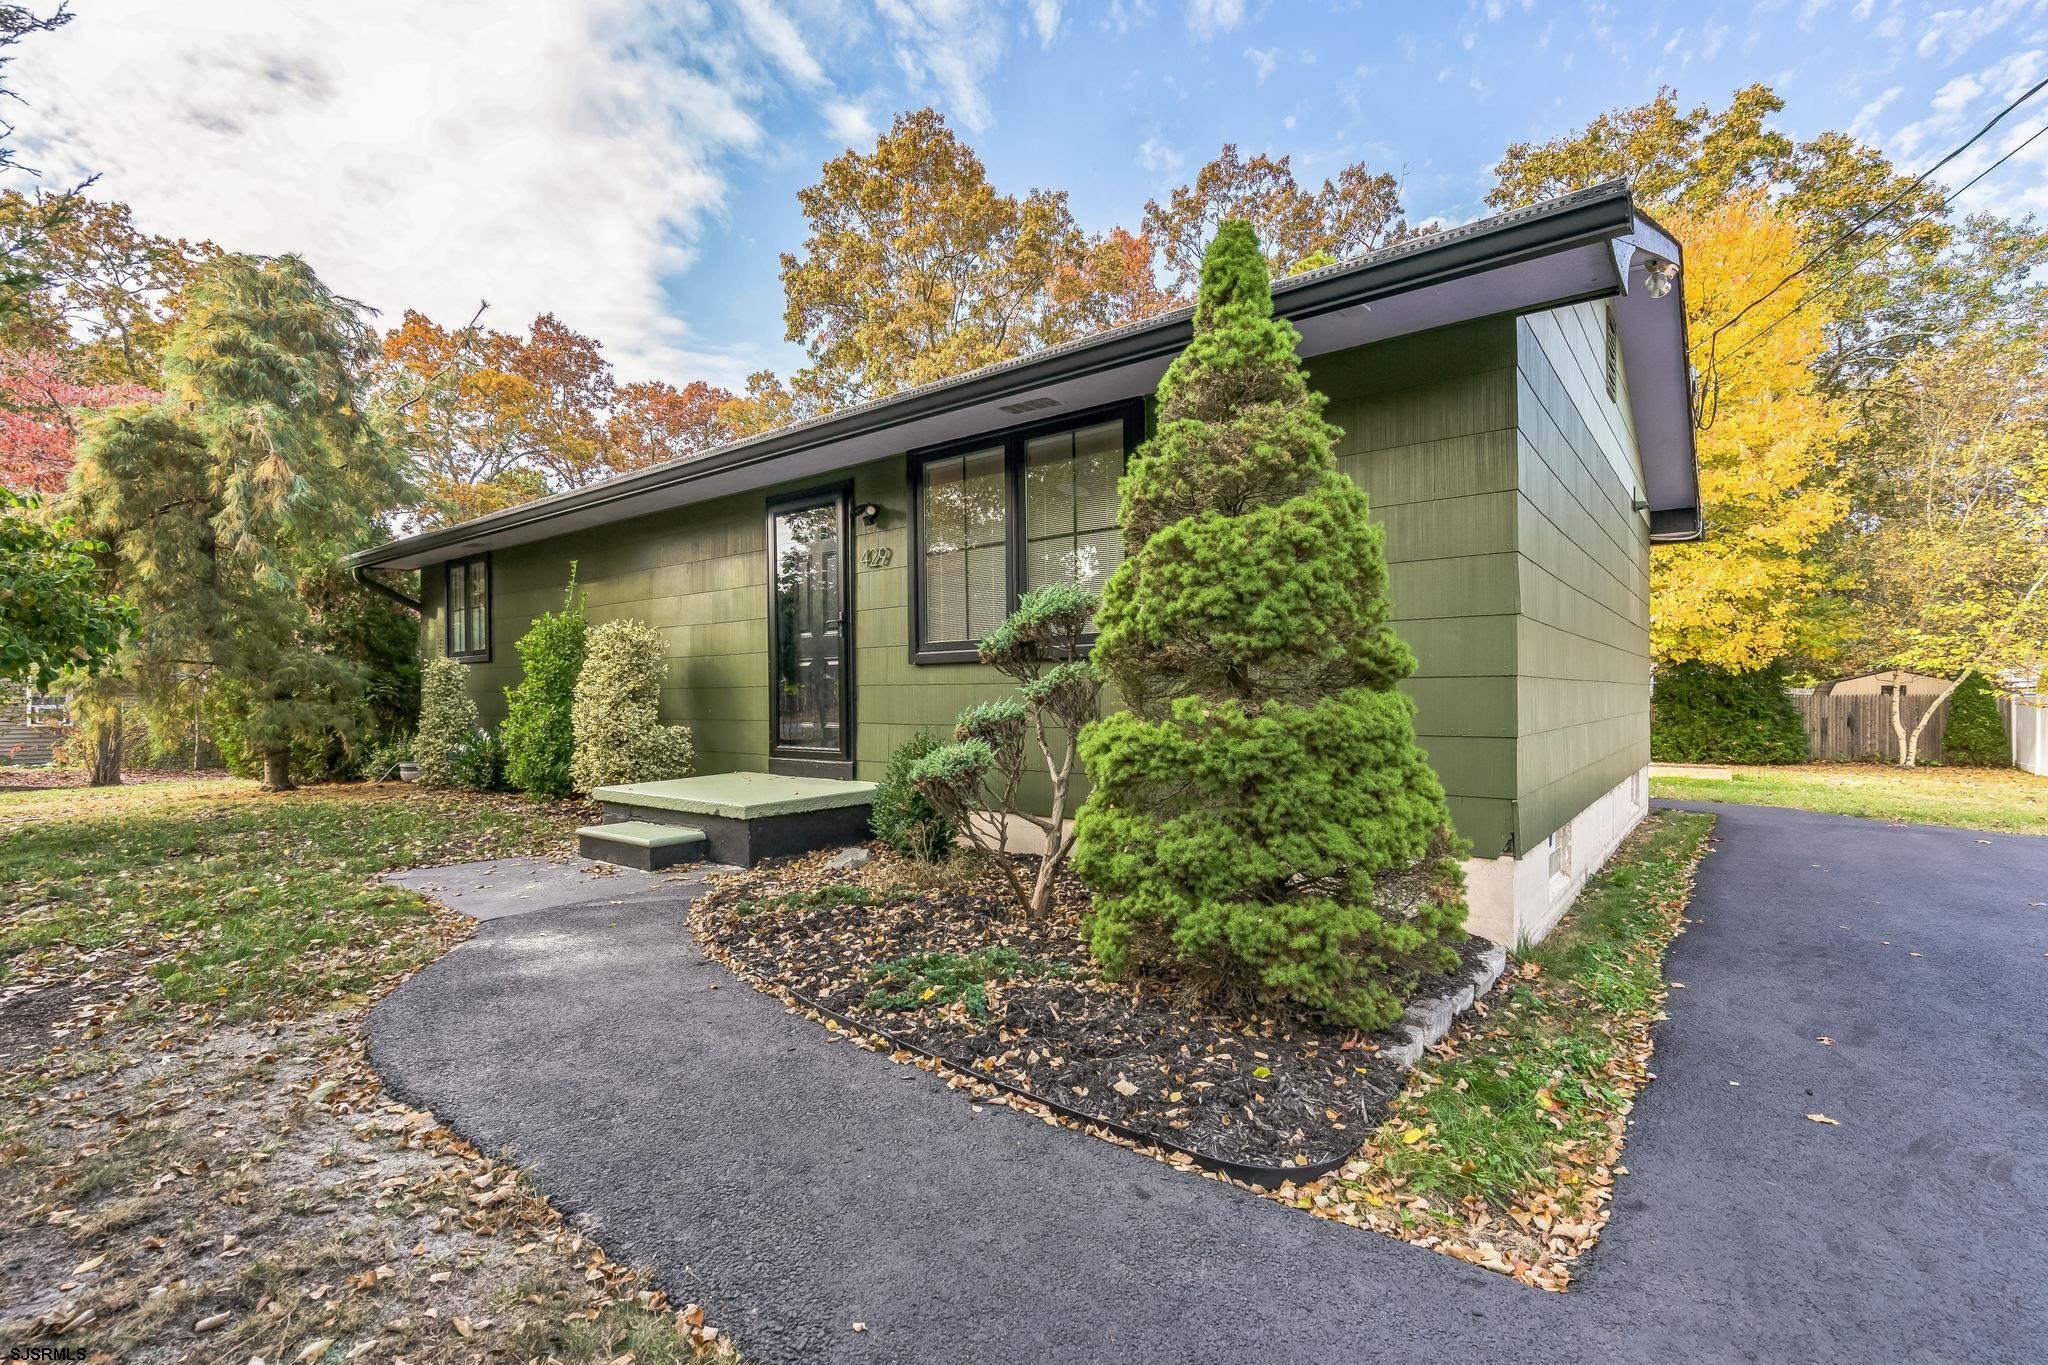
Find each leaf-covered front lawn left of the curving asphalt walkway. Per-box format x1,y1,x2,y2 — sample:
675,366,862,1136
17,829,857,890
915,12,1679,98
0,782,723,1363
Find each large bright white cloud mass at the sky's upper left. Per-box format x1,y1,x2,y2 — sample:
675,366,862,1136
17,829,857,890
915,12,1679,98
10,0,807,381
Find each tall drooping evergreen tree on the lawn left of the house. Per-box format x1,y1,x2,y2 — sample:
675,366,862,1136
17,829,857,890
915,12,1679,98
72,256,403,790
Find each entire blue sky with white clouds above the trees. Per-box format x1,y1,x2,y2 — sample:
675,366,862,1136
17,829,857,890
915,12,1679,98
14,0,2048,383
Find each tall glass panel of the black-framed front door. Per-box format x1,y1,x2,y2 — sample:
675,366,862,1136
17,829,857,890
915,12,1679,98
770,501,846,753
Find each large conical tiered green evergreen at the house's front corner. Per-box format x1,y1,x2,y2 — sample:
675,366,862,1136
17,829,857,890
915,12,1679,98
1073,221,1464,1027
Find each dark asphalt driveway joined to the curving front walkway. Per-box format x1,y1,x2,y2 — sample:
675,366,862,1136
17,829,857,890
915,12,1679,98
371,806,2048,1365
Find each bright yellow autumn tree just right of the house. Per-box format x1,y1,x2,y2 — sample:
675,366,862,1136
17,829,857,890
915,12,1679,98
1651,192,1847,669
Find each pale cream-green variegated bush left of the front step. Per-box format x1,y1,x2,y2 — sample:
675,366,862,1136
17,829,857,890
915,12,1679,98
569,620,696,792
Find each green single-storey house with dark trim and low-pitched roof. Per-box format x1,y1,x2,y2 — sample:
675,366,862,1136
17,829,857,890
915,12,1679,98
352,184,1702,943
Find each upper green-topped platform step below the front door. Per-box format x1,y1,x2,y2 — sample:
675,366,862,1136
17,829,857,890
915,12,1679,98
590,774,874,868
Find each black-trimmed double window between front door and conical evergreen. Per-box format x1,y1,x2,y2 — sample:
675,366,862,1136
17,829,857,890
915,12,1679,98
911,405,1143,663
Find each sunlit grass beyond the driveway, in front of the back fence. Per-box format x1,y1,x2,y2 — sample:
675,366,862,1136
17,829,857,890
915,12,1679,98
1651,763,2048,835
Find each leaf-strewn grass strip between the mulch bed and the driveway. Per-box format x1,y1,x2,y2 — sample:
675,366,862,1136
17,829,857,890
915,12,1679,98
1280,810,1714,1289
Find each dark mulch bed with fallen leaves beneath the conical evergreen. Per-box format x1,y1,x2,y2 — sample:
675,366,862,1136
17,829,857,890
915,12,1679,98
690,855,1485,1169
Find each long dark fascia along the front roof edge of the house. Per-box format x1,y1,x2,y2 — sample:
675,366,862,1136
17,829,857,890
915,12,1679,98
344,182,1636,567
